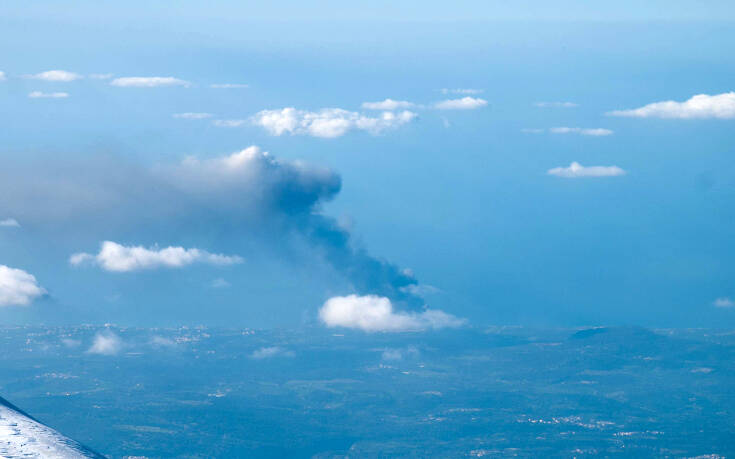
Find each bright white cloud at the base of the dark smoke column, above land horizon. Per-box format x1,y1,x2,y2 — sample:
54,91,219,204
319,295,464,332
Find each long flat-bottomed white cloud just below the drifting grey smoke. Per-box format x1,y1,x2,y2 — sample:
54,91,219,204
69,241,243,272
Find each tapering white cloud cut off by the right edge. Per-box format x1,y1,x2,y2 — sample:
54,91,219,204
607,92,735,119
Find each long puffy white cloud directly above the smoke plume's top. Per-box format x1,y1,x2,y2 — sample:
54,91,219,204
252,107,416,138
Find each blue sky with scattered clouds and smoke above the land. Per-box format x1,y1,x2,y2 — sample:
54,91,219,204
0,1,735,331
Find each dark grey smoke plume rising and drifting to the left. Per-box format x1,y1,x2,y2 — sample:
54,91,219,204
0,146,424,308
